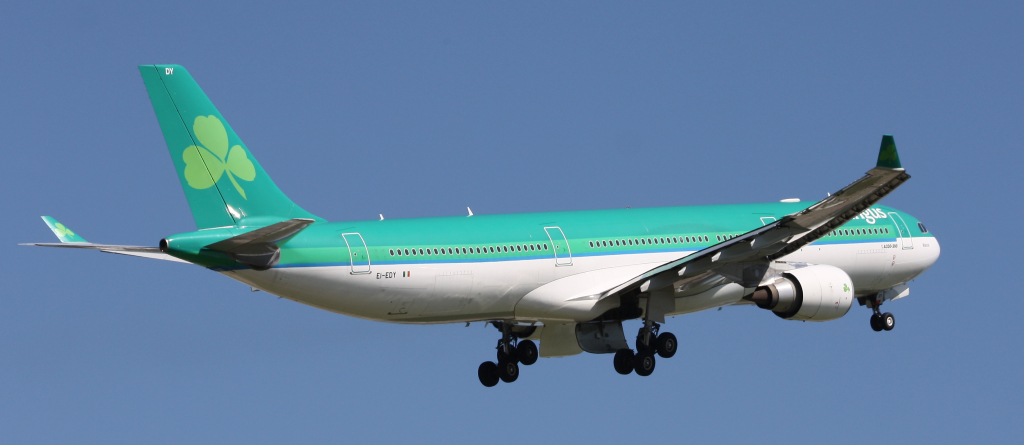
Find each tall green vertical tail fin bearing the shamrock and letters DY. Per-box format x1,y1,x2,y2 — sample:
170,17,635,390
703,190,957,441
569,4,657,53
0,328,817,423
138,64,323,229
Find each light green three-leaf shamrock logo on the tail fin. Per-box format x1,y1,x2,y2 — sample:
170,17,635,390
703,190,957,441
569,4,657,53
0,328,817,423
181,116,256,199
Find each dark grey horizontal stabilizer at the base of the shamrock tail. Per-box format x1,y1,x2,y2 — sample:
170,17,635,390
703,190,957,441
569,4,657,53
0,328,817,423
206,218,315,270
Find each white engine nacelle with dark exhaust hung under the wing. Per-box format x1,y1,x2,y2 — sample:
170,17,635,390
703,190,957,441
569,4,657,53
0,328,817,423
746,265,854,321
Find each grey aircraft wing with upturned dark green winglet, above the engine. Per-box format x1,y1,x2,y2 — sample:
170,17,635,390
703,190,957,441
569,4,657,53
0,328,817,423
600,135,910,299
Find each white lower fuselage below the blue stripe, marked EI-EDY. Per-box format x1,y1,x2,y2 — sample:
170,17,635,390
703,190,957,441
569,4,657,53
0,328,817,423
222,237,940,323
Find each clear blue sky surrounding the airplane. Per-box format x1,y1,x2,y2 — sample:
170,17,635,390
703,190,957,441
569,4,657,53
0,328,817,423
0,2,1024,444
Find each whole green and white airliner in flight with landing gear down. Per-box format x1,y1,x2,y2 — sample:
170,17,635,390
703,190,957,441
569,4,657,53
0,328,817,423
24,64,940,387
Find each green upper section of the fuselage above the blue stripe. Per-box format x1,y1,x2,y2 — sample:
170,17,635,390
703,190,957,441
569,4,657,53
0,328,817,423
237,203,931,268
